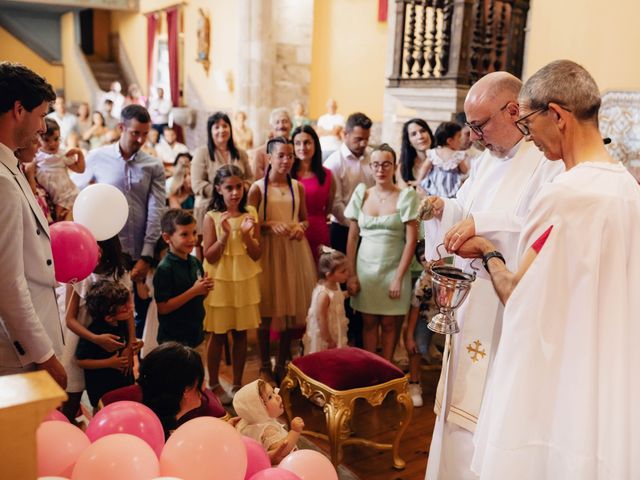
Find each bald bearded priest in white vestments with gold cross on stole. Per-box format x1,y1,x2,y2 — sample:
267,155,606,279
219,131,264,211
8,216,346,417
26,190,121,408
425,72,563,480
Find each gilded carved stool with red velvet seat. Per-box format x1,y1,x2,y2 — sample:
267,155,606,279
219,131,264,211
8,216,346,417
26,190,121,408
280,347,413,470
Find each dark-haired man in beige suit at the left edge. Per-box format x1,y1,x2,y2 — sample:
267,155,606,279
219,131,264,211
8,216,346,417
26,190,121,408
0,62,67,388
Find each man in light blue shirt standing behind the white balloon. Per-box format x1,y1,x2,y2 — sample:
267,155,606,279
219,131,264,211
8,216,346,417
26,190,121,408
78,105,166,337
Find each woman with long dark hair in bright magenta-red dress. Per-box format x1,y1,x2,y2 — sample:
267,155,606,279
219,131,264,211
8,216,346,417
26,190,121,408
291,125,336,264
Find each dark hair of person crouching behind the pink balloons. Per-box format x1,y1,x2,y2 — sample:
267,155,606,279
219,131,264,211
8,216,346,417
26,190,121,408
138,342,204,437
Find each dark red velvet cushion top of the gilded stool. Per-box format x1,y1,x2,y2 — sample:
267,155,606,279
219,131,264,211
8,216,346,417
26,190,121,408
292,347,404,390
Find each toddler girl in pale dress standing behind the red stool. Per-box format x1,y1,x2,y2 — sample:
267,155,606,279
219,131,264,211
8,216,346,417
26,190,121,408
302,246,349,355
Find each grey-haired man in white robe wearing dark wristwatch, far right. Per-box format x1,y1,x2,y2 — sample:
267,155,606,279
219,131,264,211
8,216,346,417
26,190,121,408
458,60,640,480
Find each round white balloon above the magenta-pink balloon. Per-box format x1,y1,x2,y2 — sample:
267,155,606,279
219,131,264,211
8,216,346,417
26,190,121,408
73,183,129,241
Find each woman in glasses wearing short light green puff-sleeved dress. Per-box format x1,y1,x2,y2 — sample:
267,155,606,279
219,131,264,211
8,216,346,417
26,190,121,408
345,143,418,360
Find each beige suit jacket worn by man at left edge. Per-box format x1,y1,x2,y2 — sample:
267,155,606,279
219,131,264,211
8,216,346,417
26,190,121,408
0,143,64,372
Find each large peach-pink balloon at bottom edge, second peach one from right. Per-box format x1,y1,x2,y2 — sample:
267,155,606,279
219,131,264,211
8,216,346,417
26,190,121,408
160,417,247,480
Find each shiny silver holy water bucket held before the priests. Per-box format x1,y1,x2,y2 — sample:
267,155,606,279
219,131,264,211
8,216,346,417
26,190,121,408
427,245,476,335
